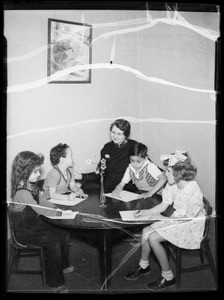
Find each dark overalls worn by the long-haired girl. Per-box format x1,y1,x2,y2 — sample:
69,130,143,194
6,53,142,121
11,189,70,287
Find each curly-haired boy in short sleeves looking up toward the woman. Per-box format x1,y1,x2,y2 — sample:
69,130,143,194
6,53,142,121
43,143,88,200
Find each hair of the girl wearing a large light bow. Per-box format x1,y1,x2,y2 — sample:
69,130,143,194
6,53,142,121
163,152,197,183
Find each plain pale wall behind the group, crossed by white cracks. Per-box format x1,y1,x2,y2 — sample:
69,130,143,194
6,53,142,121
4,10,219,206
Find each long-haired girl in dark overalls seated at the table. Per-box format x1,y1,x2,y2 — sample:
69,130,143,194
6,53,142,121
10,151,74,293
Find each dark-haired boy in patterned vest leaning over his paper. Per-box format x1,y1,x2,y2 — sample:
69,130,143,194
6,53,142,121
112,142,167,198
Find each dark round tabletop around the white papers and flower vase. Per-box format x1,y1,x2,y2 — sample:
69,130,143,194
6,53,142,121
44,191,162,230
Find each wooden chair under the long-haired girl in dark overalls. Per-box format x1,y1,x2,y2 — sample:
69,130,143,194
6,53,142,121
7,211,46,287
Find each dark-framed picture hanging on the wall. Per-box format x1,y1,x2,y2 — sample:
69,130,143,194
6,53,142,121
47,19,92,83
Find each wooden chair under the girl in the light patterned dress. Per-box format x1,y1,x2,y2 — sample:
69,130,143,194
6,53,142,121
165,198,216,288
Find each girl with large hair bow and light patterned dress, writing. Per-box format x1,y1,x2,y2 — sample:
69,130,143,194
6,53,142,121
125,149,205,291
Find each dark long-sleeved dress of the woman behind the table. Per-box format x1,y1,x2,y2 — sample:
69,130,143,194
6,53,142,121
81,140,137,193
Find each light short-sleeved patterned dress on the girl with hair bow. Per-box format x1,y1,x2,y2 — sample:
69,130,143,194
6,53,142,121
151,181,205,249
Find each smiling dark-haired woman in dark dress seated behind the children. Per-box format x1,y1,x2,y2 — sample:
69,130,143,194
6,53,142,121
75,119,136,193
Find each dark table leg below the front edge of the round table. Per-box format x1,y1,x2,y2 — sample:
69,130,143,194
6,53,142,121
99,230,112,290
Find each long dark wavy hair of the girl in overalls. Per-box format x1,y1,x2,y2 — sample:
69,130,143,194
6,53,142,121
11,151,44,198
